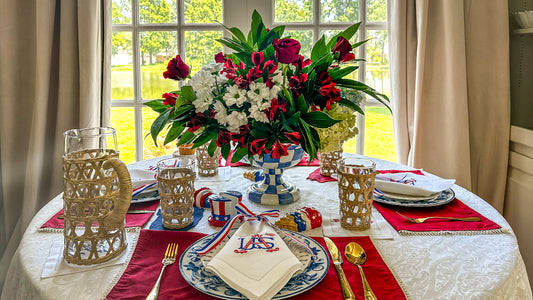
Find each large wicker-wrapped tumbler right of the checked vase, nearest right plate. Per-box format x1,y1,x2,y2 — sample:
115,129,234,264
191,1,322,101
337,157,376,230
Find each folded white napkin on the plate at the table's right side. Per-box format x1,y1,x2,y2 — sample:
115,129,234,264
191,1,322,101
374,172,455,197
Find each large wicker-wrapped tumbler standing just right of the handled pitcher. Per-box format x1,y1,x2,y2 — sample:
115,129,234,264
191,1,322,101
157,157,196,229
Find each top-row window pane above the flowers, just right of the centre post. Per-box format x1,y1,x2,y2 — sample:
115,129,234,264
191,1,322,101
274,0,313,23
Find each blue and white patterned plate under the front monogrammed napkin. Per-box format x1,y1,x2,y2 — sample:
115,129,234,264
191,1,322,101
180,231,329,300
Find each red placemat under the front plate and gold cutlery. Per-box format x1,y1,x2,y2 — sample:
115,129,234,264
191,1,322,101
107,230,405,300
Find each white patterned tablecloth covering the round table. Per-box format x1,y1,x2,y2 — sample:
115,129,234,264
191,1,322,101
1,159,532,300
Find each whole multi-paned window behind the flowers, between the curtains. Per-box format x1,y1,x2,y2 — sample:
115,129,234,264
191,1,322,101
109,0,396,163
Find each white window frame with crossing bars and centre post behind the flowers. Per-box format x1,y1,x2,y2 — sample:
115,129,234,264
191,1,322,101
104,0,388,161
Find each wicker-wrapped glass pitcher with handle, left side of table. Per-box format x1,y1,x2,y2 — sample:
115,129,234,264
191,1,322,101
63,127,132,265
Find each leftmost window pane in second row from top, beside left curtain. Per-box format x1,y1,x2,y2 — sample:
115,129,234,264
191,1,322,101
111,32,133,100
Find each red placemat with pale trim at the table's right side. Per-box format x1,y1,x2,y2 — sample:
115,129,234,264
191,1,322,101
374,198,501,234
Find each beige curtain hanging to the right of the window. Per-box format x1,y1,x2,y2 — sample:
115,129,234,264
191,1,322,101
389,0,510,212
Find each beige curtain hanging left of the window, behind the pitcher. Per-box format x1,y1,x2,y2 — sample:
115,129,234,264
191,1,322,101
0,0,111,287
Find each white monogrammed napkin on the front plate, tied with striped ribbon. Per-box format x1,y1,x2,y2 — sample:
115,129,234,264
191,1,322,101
206,221,304,300
